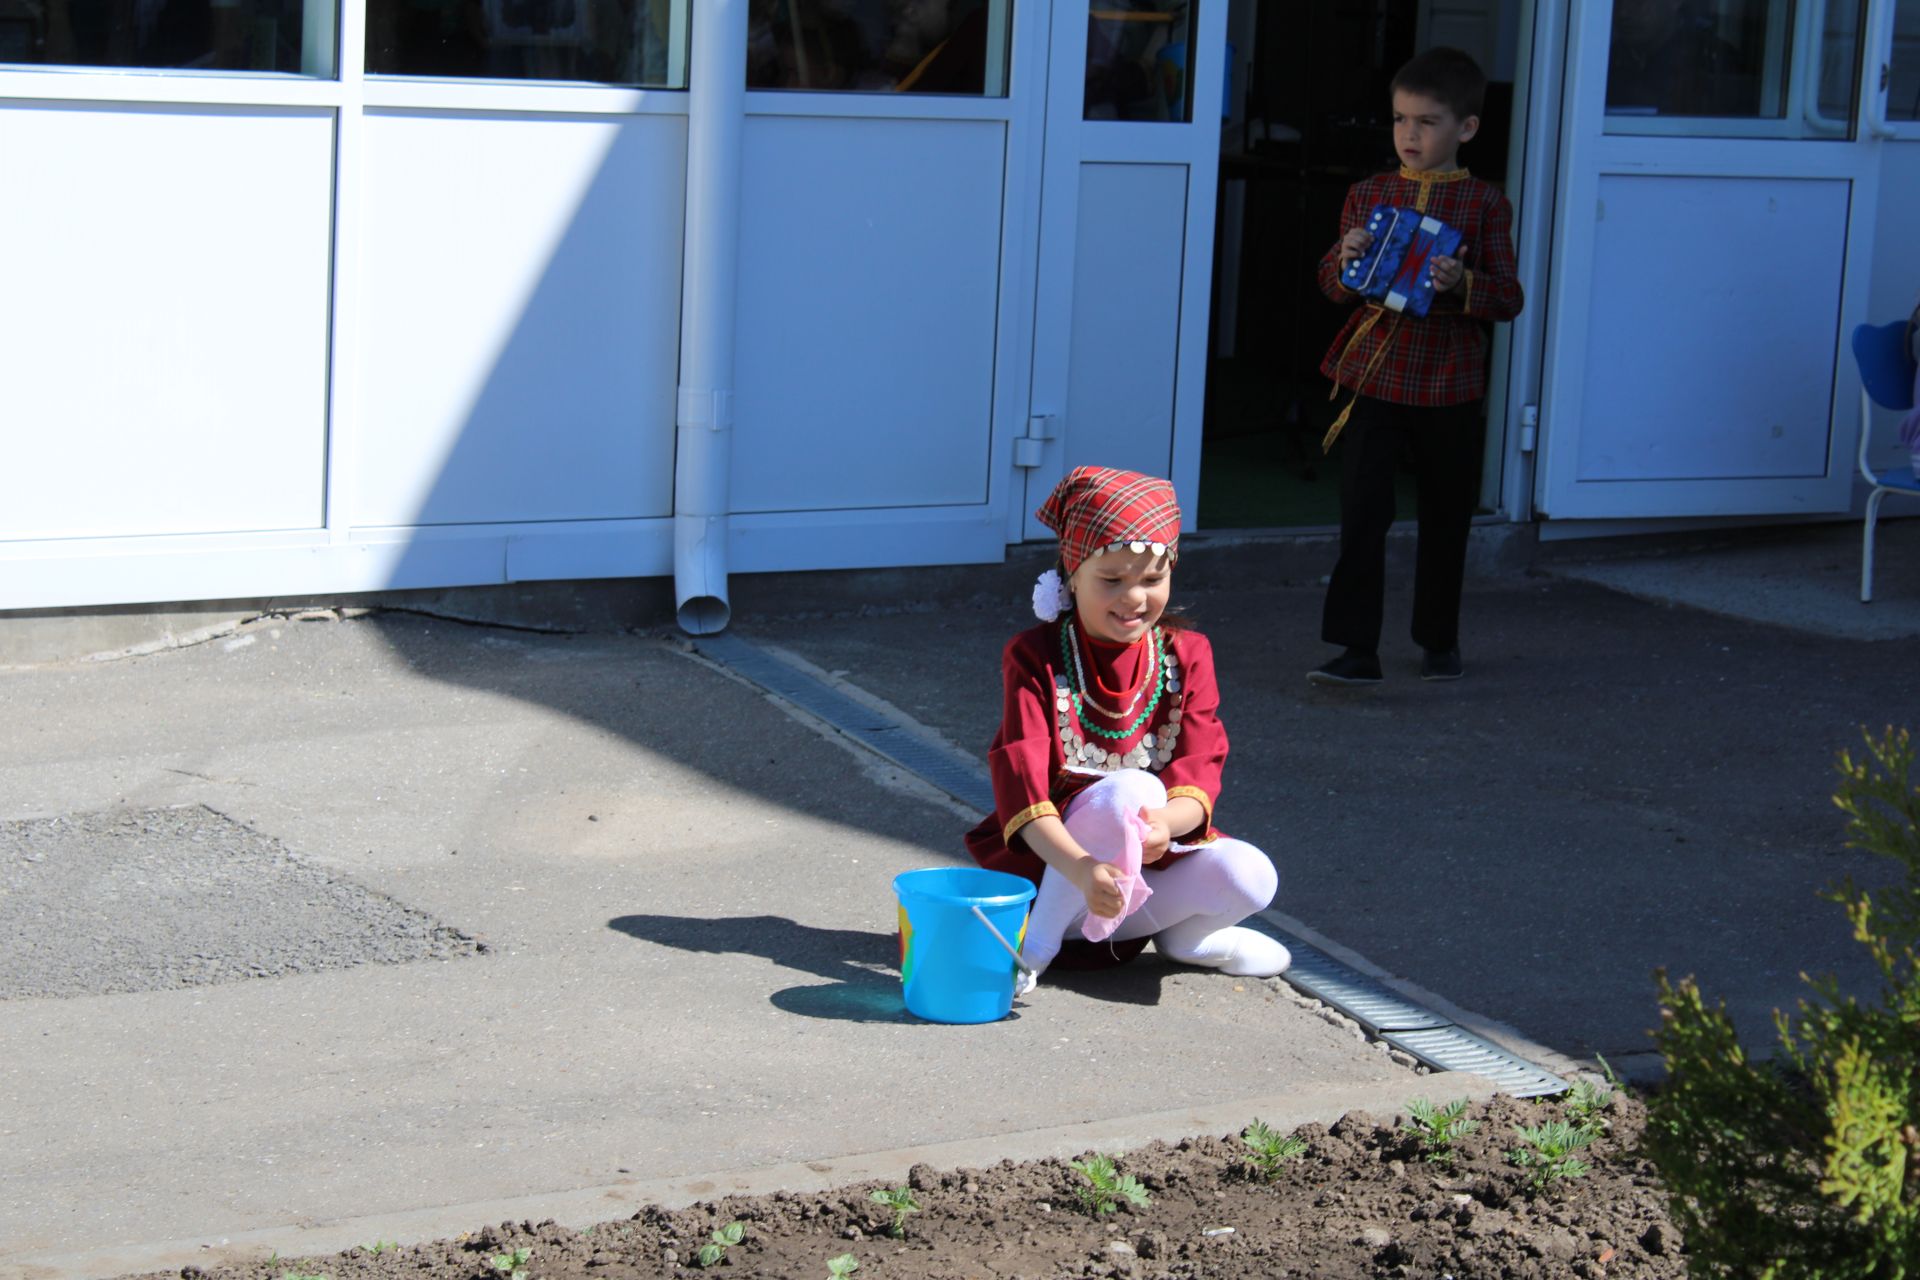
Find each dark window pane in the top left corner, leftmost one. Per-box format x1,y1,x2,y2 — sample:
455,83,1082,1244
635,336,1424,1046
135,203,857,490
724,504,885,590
0,0,334,75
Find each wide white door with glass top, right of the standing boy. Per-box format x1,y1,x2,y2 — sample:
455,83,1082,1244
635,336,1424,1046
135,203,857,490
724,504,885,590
1536,0,1880,518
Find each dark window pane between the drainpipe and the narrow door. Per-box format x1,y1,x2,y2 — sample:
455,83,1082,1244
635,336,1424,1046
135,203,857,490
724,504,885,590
747,0,1010,98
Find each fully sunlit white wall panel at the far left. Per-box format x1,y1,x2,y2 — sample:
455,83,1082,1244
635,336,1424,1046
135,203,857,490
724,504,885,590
0,104,332,539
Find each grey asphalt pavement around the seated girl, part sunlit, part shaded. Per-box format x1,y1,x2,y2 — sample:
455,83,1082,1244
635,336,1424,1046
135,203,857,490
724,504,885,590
0,522,1920,1280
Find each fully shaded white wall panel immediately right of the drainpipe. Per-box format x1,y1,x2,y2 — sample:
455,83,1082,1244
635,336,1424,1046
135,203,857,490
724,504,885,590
732,115,1006,512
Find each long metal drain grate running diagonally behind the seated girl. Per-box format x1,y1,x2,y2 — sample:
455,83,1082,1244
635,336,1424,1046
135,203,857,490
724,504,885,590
693,631,1569,1098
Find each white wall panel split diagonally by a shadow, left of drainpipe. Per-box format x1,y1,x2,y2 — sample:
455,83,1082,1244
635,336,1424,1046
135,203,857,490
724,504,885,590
349,111,685,526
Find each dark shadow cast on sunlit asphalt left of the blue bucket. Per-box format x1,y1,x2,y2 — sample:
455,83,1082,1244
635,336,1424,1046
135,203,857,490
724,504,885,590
607,915,920,1023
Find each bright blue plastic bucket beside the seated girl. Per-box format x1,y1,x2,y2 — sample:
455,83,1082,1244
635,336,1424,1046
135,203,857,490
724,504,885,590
893,867,1033,1023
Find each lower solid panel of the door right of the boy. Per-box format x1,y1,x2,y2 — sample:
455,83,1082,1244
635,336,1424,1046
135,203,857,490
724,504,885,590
1578,175,1851,480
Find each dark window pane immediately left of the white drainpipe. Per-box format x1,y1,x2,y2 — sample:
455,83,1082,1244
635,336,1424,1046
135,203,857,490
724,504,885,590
367,0,695,88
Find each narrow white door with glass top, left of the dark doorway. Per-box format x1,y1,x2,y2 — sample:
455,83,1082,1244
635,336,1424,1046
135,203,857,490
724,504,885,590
1014,0,1227,539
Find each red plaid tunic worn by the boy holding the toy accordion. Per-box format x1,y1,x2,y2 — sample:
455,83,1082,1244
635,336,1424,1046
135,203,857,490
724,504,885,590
1319,167,1524,405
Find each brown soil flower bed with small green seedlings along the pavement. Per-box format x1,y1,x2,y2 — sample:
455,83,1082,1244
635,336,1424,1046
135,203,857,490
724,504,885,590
142,1077,1686,1280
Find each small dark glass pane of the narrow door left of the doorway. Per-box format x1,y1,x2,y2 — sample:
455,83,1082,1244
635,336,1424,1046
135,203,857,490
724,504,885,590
1085,0,1194,123
